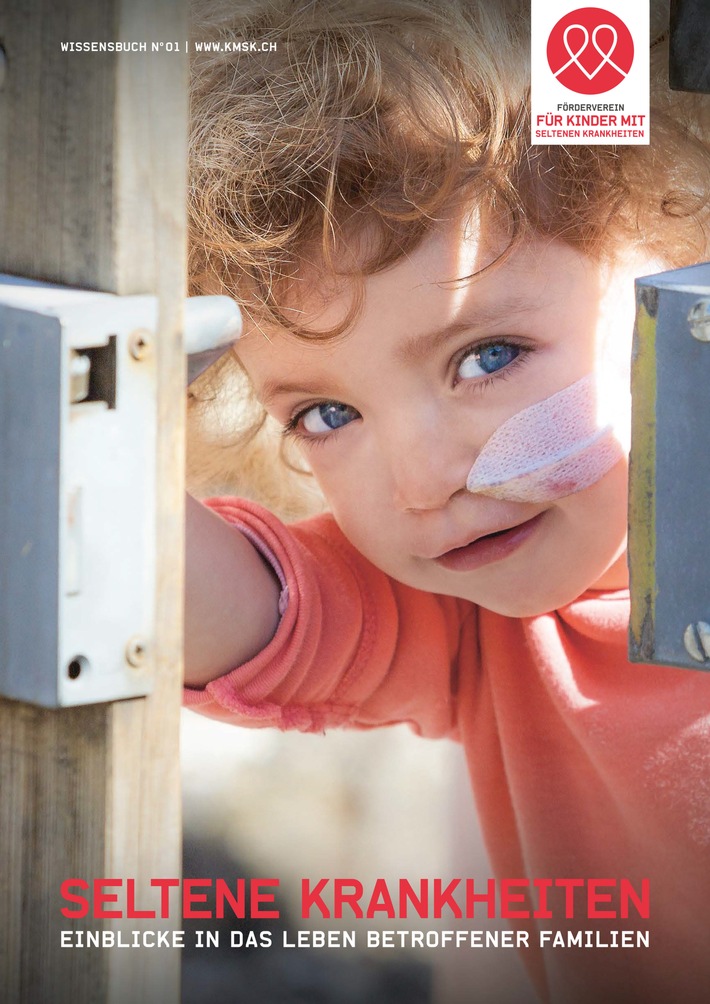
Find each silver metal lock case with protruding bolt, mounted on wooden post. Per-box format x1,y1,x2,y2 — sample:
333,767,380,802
0,276,240,707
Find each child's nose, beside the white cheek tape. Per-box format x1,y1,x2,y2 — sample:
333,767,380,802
379,413,478,511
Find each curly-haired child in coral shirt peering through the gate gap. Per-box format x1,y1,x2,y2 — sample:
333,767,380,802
186,0,710,1004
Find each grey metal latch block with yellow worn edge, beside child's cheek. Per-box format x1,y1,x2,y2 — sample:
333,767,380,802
629,263,710,670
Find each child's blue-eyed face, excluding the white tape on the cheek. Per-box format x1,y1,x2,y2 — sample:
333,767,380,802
239,213,657,616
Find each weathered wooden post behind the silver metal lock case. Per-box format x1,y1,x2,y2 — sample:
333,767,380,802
0,0,188,1004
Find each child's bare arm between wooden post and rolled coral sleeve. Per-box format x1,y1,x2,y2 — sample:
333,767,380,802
185,496,280,687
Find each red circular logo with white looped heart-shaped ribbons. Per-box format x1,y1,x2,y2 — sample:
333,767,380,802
547,7,634,94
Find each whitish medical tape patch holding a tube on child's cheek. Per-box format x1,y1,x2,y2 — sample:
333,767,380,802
466,374,630,502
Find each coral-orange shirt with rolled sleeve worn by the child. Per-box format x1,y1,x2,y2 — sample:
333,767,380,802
185,499,710,1004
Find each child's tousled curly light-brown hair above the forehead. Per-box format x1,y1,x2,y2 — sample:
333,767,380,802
190,0,710,333
